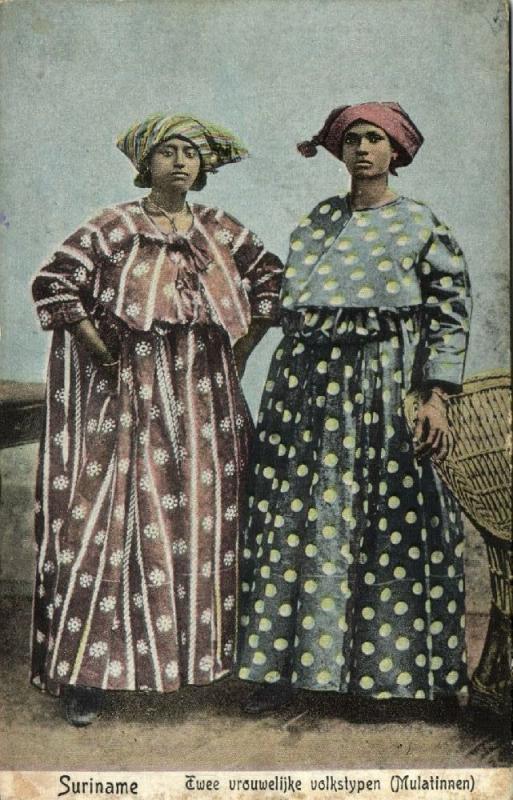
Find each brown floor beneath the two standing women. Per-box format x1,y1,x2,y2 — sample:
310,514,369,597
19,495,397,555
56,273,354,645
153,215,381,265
0,598,512,770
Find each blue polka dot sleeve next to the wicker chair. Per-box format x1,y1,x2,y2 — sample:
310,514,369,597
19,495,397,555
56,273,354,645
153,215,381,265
421,218,472,388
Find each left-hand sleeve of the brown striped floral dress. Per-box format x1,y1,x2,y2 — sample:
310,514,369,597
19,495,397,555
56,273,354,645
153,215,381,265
32,226,98,330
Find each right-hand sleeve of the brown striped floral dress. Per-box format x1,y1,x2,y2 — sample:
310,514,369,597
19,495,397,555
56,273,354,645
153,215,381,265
222,215,283,324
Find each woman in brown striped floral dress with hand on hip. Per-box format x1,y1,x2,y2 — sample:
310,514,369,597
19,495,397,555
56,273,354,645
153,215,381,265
32,115,281,724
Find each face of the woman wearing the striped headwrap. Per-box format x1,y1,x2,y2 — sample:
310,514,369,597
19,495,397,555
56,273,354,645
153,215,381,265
150,138,201,192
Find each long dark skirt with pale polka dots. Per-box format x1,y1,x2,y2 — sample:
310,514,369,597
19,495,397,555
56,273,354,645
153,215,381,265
238,310,467,698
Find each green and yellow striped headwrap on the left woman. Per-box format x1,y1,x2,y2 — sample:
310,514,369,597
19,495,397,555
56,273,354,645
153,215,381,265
116,114,248,186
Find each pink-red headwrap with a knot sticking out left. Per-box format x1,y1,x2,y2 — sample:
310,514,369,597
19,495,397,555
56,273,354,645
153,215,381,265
297,103,424,174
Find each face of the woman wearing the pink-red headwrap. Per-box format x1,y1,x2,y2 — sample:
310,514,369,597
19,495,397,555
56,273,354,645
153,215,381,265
342,122,397,178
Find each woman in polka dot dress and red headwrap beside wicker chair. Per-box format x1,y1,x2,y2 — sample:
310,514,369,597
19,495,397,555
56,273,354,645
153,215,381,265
239,103,470,712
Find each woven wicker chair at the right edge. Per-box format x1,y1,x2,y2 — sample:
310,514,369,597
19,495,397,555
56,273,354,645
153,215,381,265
405,370,513,714
